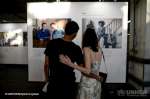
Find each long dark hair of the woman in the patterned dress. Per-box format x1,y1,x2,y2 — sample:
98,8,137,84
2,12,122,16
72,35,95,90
82,28,98,52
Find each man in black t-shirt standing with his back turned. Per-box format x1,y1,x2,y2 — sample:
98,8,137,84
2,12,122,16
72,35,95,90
44,21,83,99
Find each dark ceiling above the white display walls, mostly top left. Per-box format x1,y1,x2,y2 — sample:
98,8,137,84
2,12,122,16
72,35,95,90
0,0,128,23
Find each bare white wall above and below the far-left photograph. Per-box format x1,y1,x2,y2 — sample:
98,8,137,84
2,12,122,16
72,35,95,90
0,23,28,64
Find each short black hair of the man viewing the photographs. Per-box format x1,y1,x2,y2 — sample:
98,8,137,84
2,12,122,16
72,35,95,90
65,21,79,35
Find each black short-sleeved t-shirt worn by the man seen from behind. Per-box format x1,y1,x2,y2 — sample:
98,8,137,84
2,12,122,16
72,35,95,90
44,39,83,83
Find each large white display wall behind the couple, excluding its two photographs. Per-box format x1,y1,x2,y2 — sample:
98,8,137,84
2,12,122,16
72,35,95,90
27,2,128,83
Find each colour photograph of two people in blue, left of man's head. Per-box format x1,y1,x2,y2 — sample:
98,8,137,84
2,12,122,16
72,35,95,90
32,18,70,48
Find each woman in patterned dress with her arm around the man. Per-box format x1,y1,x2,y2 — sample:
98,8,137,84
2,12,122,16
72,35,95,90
60,28,102,99
